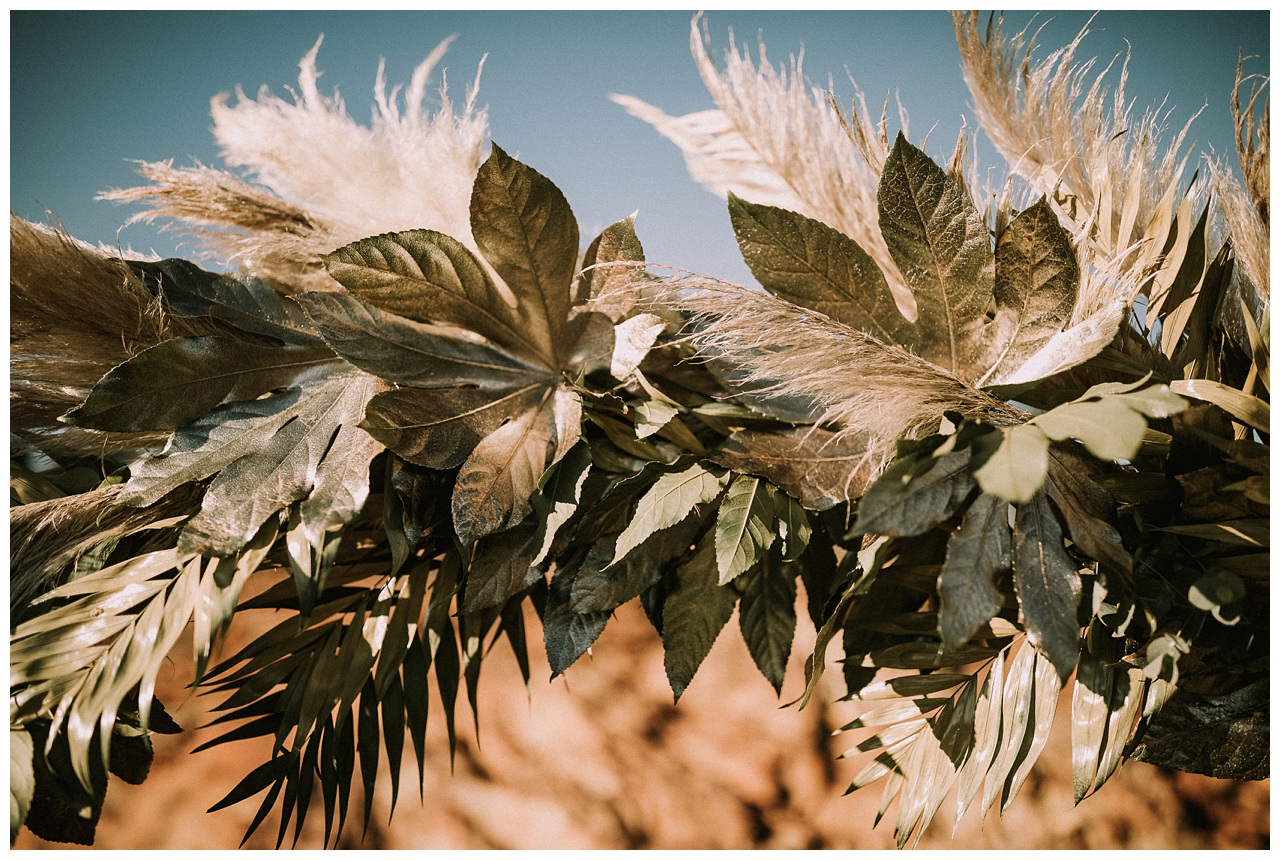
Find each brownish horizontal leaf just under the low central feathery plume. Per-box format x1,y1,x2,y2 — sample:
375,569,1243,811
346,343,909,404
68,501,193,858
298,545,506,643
710,427,872,511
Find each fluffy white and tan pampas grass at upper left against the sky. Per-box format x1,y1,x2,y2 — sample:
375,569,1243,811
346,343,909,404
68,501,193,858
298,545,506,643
101,34,489,292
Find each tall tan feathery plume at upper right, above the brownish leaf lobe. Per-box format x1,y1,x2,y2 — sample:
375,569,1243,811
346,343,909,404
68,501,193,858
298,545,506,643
952,12,1204,321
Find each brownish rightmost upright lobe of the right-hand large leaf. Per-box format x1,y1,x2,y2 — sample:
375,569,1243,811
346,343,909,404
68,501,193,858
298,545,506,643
978,197,1080,384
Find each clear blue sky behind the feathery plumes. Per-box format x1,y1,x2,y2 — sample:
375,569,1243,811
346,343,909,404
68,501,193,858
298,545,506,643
10,10,1270,282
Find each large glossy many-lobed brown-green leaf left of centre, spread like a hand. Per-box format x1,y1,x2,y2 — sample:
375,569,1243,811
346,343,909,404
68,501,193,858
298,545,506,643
300,146,614,543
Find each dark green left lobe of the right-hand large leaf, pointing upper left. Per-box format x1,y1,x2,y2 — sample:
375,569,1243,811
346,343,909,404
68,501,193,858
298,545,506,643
728,192,916,347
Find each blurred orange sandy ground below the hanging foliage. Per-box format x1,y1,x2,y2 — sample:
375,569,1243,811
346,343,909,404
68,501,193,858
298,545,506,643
15,604,1271,850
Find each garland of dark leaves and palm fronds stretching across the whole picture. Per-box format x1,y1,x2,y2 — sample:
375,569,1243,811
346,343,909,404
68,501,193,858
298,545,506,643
10,15,1270,846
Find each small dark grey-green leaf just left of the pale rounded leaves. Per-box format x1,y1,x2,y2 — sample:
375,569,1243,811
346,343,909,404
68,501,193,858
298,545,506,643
854,449,974,538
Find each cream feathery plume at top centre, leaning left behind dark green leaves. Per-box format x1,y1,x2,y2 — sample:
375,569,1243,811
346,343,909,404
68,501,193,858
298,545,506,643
609,15,915,313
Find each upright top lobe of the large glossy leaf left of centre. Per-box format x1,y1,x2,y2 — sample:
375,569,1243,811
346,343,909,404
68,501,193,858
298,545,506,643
471,145,588,366
